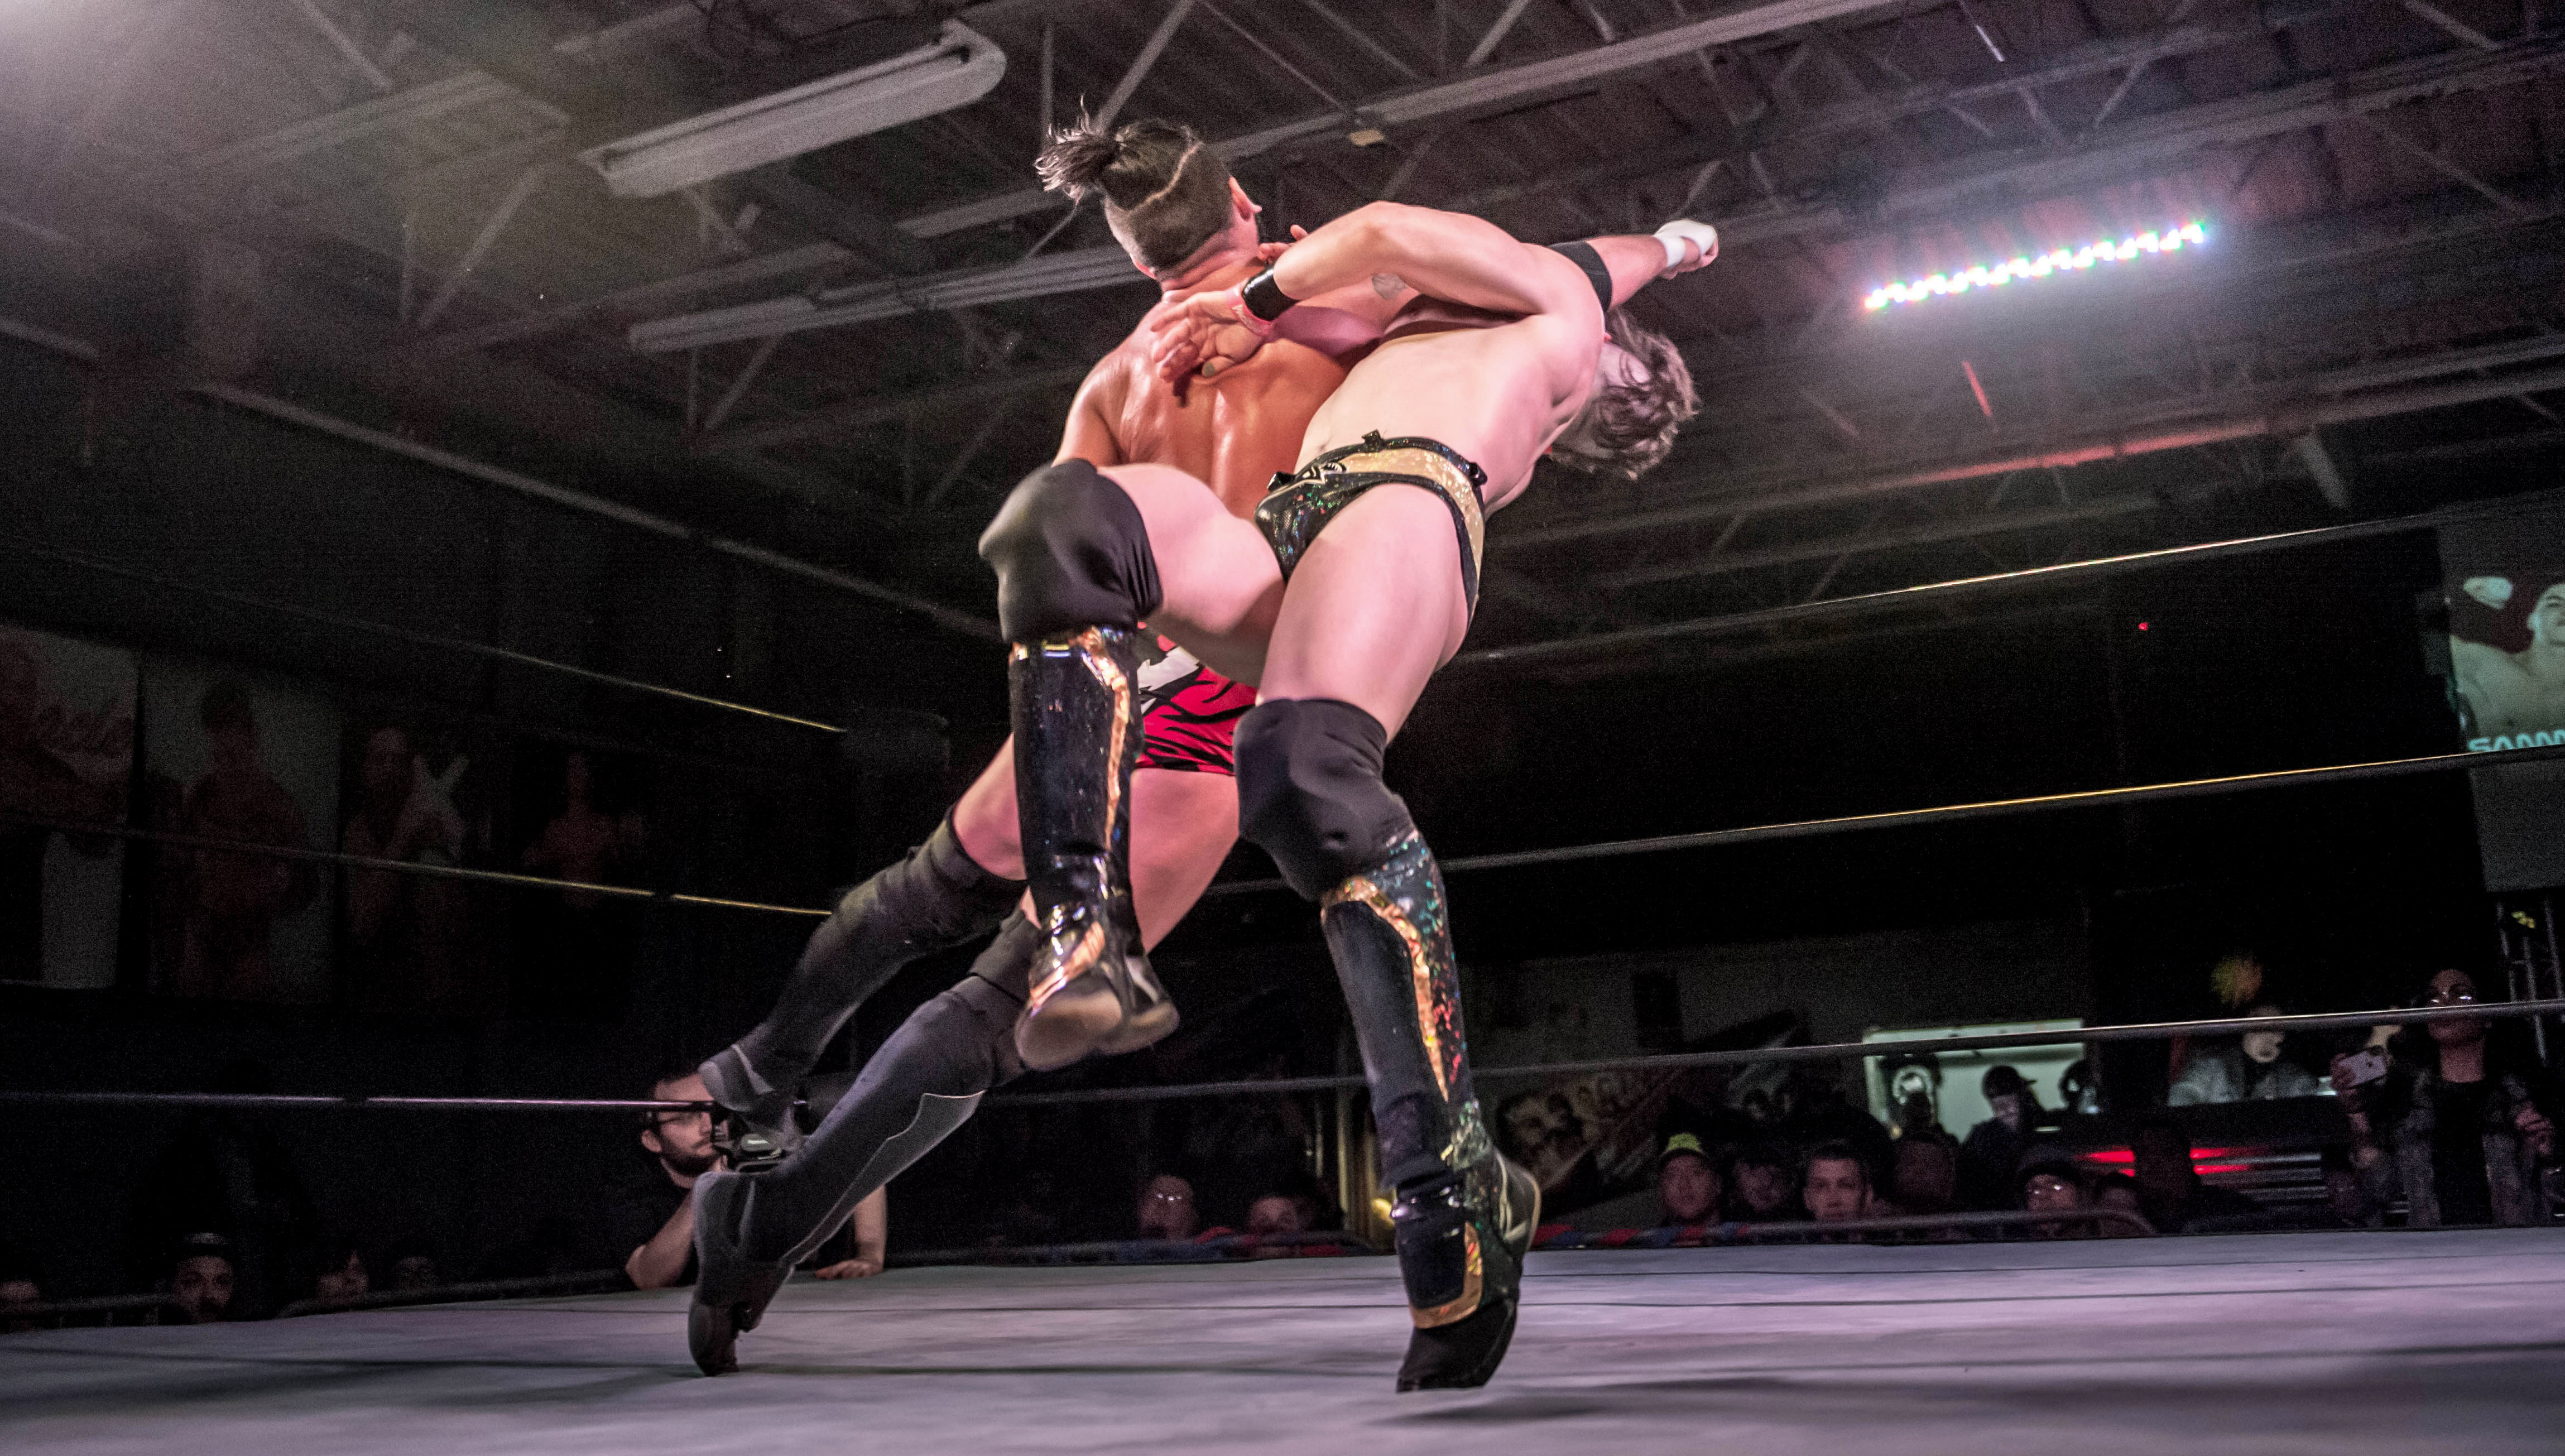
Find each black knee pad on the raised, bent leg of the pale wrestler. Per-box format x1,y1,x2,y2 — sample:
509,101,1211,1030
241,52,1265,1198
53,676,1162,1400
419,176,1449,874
980,459,1159,641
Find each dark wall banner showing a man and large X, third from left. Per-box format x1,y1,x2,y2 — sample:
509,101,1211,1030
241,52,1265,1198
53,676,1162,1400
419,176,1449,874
339,713,508,1012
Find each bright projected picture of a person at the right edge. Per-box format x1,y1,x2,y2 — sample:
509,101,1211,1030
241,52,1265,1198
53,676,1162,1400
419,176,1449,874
2439,504,2565,753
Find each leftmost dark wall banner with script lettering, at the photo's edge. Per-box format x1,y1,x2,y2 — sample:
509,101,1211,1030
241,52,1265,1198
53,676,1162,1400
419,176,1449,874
0,626,136,989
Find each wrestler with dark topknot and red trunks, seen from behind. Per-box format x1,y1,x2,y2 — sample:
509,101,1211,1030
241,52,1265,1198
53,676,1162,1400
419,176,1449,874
690,121,1390,1374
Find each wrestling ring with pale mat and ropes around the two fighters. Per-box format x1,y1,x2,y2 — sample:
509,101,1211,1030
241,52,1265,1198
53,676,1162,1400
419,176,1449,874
0,504,2565,1456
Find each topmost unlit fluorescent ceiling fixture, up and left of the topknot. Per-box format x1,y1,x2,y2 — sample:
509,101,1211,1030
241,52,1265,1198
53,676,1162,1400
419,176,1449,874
580,21,1006,198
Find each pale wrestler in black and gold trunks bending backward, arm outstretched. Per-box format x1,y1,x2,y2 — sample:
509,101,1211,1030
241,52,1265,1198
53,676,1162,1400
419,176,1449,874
980,205,1716,1390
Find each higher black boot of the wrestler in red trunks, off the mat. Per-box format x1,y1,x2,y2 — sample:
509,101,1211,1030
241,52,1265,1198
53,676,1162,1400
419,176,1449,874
703,815,1024,1149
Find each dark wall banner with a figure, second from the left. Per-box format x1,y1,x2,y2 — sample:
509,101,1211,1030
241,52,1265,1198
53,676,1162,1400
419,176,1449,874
141,659,339,1002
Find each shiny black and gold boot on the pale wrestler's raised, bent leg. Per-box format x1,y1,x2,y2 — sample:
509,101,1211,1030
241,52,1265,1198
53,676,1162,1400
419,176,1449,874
1008,626,1178,1071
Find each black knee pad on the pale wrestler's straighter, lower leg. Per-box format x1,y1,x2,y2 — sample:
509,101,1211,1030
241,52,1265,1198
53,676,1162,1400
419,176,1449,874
1236,697,1416,900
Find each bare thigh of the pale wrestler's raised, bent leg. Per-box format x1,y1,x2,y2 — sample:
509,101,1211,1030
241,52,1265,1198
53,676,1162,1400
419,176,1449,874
1106,464,1282,684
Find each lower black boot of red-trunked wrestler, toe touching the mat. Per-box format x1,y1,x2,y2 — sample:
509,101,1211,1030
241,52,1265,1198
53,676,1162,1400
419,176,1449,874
688,915,1039,1374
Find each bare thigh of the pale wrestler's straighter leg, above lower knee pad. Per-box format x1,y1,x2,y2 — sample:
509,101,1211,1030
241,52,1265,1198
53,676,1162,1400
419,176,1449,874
1260,484,1470,733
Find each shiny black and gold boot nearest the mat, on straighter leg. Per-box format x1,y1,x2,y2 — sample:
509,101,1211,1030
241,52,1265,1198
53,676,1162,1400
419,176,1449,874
1321,828,1541,1390
